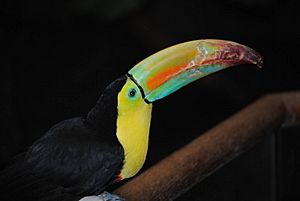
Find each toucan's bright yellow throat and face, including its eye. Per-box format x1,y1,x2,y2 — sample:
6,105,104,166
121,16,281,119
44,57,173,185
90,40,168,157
117,78,152,178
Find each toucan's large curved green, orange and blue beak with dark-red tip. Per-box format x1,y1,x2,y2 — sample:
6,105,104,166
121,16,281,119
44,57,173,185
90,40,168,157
128,40,263,102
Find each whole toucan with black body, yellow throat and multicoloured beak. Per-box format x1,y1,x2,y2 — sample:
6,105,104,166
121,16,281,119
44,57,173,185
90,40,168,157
0,39,263,201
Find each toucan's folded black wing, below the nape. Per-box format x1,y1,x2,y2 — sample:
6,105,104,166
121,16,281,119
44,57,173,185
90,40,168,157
1,118,123,200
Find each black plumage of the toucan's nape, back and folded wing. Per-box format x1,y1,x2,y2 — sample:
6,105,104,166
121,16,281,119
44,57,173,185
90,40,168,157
0,76,127,201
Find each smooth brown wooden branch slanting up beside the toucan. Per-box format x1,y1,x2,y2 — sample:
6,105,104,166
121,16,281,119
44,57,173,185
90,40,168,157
114,92,300,201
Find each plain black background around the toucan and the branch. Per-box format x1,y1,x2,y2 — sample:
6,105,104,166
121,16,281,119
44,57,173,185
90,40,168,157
0,0,300,201
